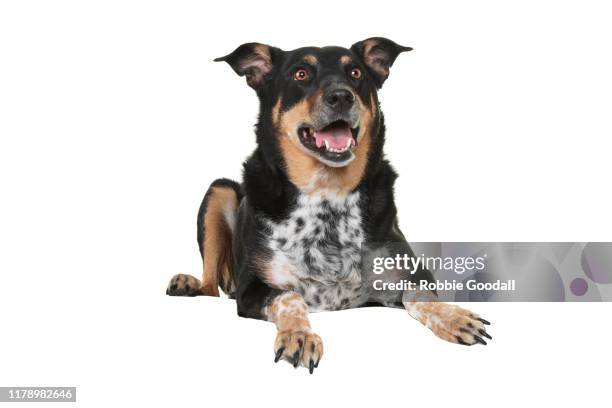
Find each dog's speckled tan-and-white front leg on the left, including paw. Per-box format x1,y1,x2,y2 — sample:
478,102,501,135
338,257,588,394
263,291,323,374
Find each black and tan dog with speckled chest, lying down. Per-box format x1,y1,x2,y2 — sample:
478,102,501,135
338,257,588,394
167,38,490,373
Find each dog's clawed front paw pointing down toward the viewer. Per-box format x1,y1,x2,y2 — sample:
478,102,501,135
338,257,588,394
274,330,323,374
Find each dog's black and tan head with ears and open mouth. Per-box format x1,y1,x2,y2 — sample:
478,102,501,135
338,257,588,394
215,38,411,189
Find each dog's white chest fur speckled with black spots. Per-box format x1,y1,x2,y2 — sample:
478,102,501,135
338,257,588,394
267,193,364,310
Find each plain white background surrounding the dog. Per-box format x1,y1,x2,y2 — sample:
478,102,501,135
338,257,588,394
0,0,612,407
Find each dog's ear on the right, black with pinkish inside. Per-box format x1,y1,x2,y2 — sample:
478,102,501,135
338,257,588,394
351,37,412,88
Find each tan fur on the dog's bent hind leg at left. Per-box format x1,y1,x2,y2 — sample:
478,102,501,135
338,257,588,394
201,187,238,296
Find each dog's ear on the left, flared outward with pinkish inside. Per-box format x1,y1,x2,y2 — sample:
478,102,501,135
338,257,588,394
215,43,282,90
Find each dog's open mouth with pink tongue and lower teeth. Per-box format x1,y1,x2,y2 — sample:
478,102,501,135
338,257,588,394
298,120,359,165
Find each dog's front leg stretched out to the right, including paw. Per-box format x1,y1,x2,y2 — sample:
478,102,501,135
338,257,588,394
402,290,491,346
